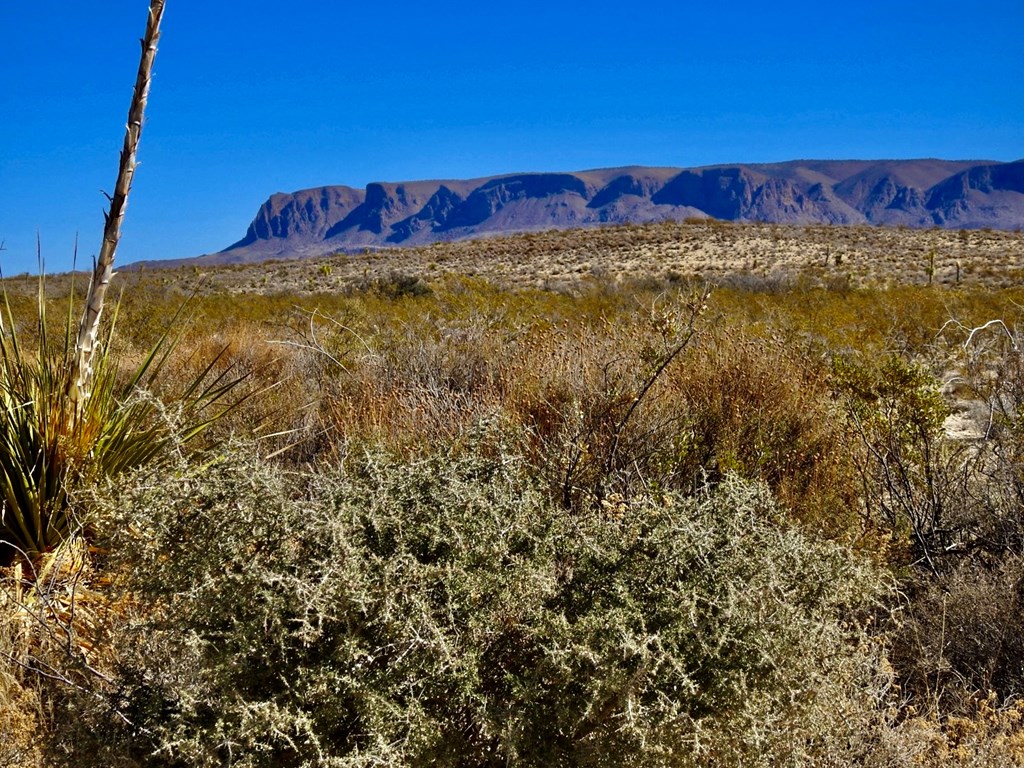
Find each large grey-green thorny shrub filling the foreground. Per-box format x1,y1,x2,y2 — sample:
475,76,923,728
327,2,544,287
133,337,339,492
60,435,881,766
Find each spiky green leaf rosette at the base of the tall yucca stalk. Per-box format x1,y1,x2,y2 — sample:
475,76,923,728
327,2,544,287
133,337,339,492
0,279,243,560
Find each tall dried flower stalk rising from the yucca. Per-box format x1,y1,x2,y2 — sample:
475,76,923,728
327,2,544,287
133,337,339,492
68,0,164,408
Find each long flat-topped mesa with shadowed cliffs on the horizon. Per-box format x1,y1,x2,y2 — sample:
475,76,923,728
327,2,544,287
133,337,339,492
208,160,1024,261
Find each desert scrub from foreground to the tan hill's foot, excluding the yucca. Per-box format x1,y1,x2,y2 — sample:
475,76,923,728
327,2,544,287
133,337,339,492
6,264,1024,766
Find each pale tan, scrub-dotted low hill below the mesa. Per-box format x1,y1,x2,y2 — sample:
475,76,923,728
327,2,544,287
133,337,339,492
125,221,1024,294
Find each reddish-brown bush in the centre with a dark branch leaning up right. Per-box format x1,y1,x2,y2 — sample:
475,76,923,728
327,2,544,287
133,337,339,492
510,289,709,509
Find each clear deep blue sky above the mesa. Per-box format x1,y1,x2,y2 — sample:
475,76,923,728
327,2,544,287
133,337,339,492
0,0,1024,274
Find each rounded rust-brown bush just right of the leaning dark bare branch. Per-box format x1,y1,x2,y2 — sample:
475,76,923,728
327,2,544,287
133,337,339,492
662,332,865,542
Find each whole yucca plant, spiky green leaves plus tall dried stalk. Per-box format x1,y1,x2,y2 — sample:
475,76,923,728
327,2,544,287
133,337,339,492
0,0,240,560
